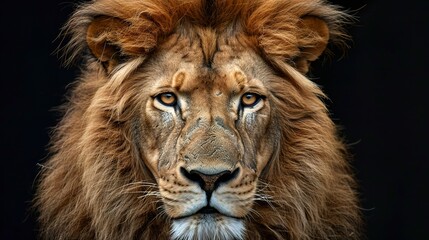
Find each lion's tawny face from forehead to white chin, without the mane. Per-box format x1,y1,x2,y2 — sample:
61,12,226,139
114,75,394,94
137,36,278,239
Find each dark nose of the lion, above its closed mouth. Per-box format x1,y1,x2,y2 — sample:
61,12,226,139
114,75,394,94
180,167,239,194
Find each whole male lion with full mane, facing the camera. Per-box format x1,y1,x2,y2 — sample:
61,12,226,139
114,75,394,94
36,0,361,240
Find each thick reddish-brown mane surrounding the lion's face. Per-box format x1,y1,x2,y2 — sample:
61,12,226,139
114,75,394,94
37,0,360,239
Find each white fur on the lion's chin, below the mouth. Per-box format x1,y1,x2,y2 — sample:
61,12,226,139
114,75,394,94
171,214,245,240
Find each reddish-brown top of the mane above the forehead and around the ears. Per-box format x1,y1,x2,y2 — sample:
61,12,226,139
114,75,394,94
65,0,351,68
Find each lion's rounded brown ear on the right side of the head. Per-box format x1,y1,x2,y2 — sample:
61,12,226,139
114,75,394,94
295,16,329,74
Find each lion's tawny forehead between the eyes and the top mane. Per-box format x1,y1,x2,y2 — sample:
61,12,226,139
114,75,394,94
154,33,271,95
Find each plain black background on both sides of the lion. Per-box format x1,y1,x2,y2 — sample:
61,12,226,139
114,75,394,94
0,0,429,240
